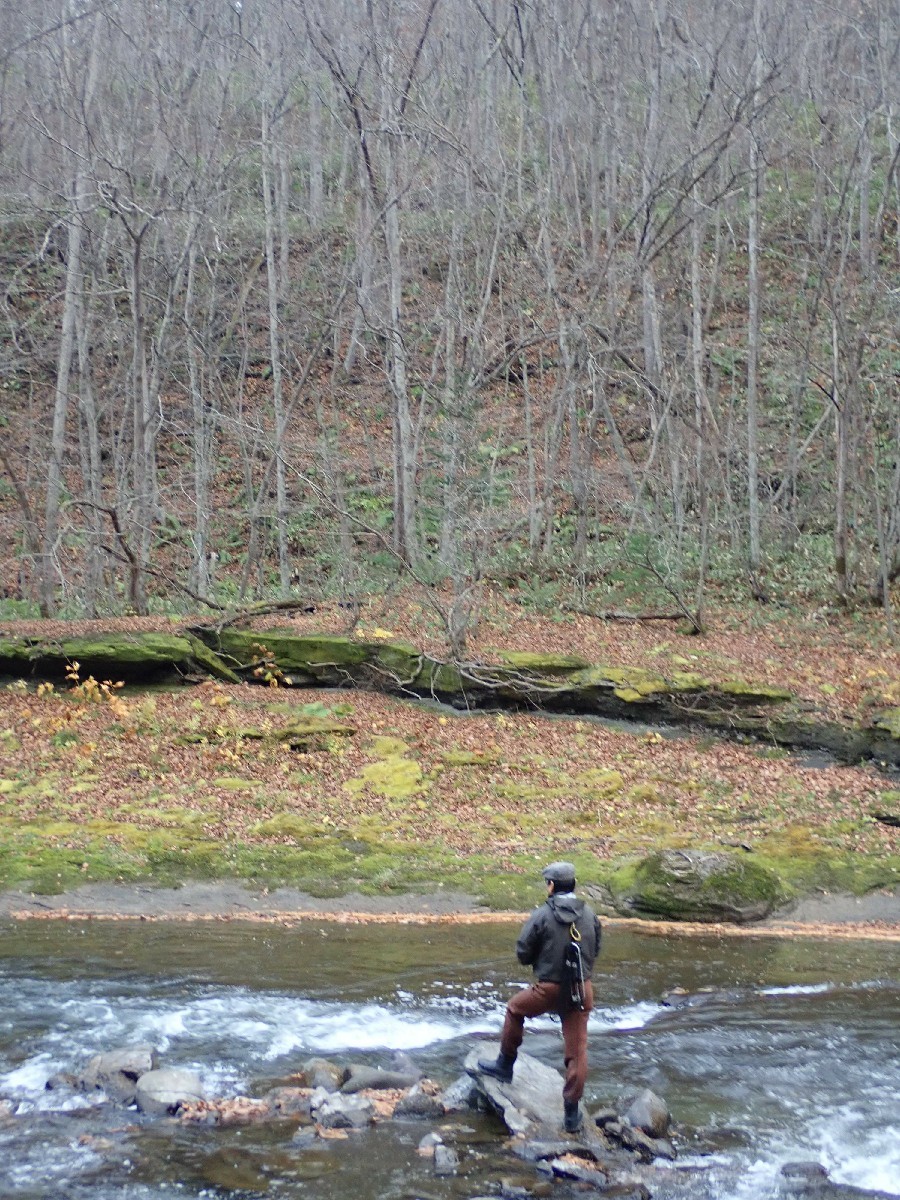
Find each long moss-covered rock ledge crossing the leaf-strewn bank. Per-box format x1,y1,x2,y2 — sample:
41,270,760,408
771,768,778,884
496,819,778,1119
0,626,900,767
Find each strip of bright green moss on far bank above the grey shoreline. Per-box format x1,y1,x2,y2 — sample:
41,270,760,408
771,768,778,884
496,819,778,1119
0,810,900,910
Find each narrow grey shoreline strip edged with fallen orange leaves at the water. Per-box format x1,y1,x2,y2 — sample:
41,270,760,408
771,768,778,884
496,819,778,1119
0,881,900,941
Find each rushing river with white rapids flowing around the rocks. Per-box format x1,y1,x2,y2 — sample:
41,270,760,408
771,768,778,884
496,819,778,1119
0,922,900,1200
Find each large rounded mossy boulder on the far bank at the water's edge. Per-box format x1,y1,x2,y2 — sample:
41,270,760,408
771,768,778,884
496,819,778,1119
611,850,784,924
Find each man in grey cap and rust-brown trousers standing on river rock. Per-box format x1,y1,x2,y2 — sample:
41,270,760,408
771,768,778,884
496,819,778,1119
478,863,600,1133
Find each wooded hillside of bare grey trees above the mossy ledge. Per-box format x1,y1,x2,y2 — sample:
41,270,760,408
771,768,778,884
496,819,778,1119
0,0,900,652
